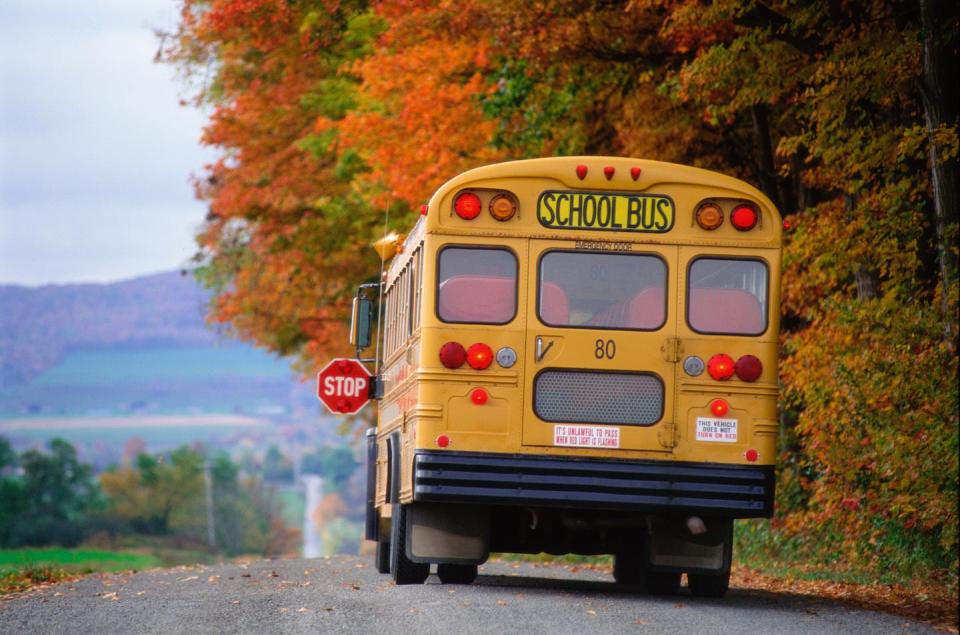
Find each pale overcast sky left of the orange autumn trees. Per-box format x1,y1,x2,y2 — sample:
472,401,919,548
0,0,213,285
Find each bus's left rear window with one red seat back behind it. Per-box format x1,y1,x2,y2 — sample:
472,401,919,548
437,247,517,324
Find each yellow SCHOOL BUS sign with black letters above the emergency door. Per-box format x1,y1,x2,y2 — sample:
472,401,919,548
537,190,676,233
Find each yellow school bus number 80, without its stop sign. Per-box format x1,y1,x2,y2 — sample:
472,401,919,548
351,157,781,596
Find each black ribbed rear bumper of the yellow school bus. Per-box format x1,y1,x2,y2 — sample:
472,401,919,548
413,451,774,518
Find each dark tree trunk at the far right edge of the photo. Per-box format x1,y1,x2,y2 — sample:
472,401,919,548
920,0,960,346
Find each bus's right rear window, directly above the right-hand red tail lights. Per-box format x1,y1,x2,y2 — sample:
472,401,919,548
687,258,768,335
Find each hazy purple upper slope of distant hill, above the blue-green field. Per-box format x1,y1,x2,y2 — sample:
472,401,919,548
0,271,218,388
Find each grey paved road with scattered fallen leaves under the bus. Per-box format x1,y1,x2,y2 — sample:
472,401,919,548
0,556,936,635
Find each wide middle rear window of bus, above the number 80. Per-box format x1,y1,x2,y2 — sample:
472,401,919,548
537,251,667,331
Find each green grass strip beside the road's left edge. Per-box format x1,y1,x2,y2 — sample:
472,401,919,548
0,548,163,594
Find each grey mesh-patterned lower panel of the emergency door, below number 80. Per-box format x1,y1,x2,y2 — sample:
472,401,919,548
533,370,663,426
